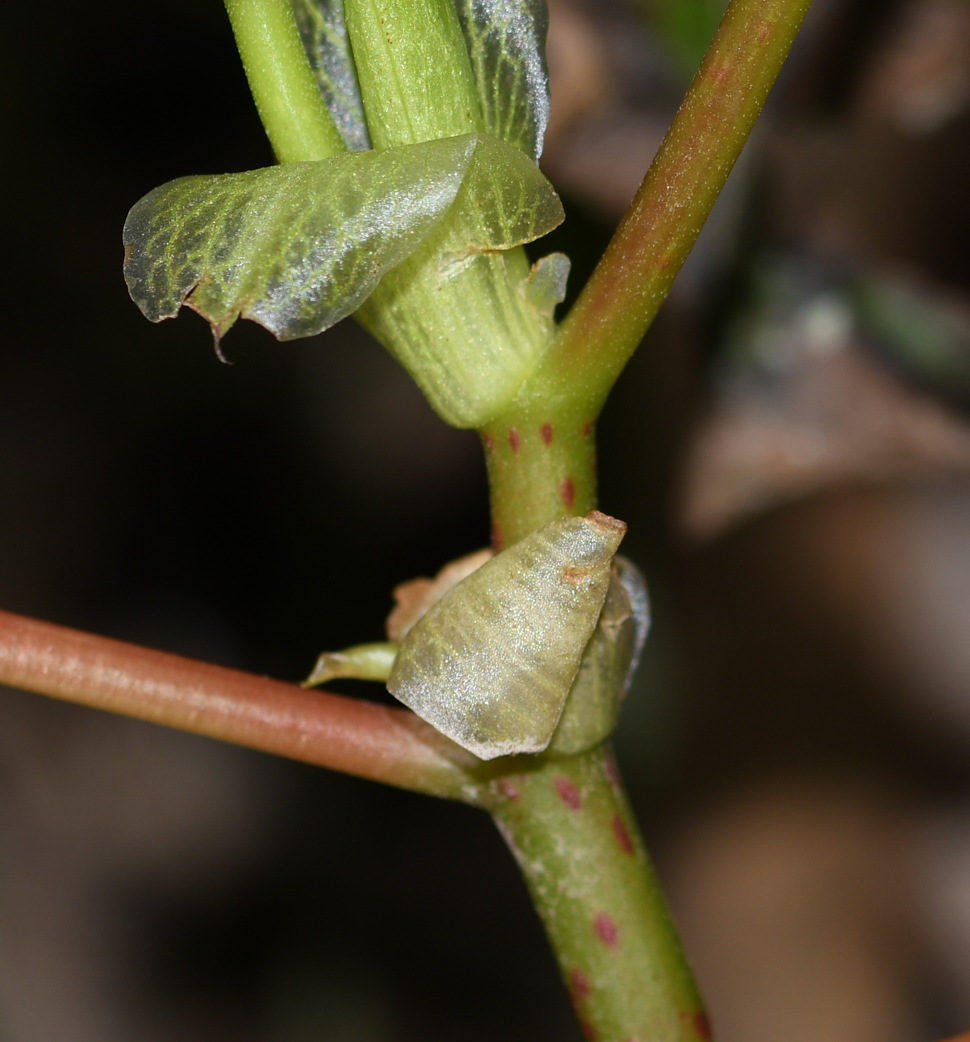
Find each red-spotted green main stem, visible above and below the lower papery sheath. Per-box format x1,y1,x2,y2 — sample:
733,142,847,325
481,389,710,1042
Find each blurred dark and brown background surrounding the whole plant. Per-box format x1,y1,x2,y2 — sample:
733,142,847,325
0,0,970,1042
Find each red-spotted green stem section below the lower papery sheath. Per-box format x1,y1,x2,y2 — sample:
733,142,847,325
491,746,711,1042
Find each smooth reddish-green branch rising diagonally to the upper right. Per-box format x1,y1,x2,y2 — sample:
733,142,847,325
520,0,811,418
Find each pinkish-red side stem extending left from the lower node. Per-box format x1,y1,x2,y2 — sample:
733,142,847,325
0,612,478,802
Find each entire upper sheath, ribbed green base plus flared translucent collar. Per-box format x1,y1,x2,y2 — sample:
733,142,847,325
124,134,563,426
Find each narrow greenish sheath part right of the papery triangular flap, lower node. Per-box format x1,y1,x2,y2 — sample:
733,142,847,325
549,556,650,755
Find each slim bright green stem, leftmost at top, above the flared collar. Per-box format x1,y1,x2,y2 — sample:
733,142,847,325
225,0,347,163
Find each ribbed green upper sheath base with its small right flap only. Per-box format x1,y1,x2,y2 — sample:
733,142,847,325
357,134,564,427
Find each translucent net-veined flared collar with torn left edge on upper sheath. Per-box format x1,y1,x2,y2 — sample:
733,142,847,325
124,134,562,340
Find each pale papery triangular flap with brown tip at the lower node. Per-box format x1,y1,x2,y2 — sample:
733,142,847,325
388,511,626,760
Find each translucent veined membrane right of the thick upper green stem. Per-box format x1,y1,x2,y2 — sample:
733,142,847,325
454,0,549,162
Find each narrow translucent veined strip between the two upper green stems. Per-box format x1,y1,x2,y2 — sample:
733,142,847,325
290,0,371,151
